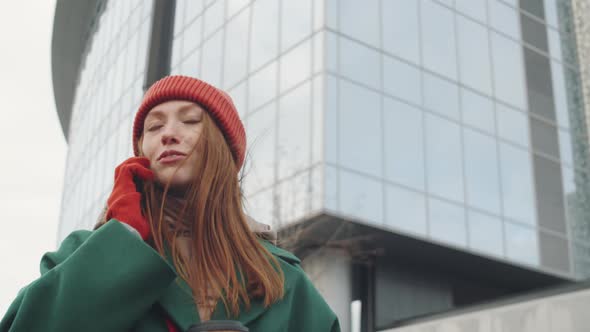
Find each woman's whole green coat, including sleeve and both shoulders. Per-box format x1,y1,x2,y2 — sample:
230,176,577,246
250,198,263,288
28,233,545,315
0,220,340,332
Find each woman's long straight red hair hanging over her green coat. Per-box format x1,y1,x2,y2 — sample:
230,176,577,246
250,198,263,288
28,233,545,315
95,112,284,316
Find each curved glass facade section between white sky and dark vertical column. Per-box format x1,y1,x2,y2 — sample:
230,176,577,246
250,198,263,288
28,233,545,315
58,0,152,241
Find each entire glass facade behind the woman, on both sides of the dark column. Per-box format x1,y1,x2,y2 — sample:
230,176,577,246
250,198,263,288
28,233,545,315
61,0,590,278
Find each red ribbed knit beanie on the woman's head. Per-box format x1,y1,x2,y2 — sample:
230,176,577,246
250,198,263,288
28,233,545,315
133,76,246,169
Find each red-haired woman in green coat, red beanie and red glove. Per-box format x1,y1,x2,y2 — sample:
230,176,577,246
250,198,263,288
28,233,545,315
0,76,340,331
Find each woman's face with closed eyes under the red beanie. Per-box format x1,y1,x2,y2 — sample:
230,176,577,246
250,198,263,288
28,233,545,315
141,100,204,189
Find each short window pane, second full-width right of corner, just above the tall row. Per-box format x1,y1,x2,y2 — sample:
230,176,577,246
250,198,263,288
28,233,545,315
383,56,422,105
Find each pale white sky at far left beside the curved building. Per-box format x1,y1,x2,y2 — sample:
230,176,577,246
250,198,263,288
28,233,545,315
0,0,67,317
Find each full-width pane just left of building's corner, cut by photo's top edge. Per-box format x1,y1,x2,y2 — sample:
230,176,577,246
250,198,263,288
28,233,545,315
281,0,311,51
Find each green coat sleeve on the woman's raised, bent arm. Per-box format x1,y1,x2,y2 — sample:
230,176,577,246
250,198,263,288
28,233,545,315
0,219,176,332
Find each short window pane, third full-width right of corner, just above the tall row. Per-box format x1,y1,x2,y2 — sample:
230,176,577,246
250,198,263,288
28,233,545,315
424,73,459,120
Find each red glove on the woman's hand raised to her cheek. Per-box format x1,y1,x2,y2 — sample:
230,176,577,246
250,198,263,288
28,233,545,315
107,157,154,240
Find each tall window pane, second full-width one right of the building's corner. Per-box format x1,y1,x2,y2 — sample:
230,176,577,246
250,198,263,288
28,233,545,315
383,98,424,190
